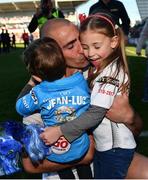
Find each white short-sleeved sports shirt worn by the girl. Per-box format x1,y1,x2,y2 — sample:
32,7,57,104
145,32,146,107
91,61,136,151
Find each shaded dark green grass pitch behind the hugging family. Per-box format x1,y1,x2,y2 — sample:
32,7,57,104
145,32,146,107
0,45,148,179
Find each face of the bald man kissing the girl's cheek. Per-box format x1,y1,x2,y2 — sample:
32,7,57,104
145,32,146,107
50,24,88,68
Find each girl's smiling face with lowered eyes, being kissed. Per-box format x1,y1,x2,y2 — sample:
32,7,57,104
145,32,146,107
80,30,118,67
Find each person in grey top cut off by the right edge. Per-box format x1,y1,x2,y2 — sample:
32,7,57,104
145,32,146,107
136,18,148,102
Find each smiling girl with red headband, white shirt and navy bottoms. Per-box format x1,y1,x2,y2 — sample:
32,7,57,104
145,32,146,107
41,14,136,179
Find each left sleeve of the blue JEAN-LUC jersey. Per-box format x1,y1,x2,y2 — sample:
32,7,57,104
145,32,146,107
16,89,39,116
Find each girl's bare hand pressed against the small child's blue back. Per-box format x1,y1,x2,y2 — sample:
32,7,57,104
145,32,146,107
40,126,62,145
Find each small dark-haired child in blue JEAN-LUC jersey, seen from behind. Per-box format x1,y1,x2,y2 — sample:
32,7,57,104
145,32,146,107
16,38,90,178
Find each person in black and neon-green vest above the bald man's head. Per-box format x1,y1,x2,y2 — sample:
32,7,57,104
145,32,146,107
28,0,64,36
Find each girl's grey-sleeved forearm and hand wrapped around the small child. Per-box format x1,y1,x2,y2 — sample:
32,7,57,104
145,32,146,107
40,105,107,145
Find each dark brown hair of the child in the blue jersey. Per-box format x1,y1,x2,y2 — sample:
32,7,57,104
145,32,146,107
24,37,66,81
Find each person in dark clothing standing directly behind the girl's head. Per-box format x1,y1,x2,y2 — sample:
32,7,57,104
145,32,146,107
89,0,130,40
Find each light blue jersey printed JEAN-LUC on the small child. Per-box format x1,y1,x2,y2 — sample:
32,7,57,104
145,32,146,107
16,72,90,163
